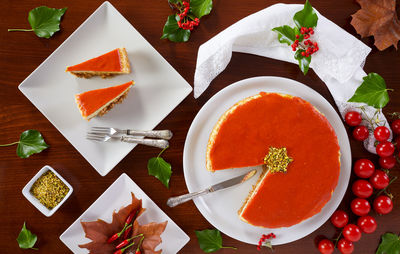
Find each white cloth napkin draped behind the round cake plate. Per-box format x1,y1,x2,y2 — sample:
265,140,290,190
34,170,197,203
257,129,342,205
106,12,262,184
194,4,389,153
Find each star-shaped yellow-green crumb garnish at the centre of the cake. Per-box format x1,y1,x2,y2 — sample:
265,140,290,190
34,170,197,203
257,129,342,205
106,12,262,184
264,147,293,173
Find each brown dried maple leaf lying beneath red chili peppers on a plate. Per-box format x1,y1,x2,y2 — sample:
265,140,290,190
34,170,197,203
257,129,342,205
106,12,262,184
79,193,167,254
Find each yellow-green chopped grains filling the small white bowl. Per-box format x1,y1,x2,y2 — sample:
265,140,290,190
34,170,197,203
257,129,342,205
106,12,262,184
30,170,69,209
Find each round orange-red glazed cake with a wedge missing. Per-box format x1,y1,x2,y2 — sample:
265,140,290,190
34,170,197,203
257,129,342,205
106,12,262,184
206,92,340,228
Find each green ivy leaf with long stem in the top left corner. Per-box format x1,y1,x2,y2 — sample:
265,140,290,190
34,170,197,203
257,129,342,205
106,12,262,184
8,6,67,39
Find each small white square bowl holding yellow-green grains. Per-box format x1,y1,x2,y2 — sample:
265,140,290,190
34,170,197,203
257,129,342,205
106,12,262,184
22,165,73,217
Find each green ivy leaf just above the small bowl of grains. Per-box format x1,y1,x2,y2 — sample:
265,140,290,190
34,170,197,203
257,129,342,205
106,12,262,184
17,130,49,158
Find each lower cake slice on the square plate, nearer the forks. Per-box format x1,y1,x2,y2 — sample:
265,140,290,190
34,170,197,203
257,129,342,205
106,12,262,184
75,81,134,121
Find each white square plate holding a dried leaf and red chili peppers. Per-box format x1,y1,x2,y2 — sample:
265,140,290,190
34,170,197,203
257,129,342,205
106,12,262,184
60,174,189,254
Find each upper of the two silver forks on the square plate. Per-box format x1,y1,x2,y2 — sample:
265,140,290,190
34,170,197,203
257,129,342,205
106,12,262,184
89,127,172,140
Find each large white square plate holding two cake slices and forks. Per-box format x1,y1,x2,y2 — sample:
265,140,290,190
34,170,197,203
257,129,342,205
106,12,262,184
19,2,192,176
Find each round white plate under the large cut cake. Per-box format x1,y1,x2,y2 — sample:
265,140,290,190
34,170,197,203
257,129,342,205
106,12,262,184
183,77,351,245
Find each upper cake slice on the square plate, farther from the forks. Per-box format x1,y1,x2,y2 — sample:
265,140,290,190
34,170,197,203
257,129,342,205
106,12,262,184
65,48,131,78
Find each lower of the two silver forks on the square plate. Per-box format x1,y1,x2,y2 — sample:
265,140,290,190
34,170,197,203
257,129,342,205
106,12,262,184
86,133,169,149
